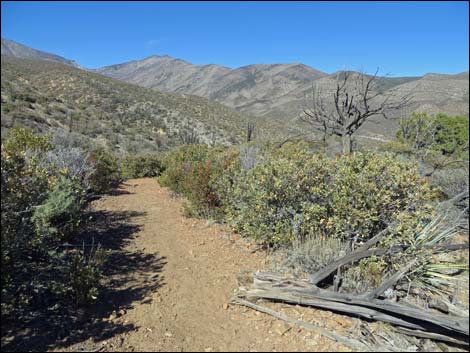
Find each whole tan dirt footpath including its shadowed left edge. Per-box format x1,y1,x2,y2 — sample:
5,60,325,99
5,179,359,352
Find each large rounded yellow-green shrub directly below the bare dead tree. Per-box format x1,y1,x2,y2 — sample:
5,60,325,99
220,144,436,244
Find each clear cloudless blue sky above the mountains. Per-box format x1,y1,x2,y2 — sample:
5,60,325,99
1,1,469,76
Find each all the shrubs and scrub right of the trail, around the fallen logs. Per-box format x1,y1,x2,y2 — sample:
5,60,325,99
159,110,468,296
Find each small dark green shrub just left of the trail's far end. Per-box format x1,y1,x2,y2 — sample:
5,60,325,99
89,147,121,194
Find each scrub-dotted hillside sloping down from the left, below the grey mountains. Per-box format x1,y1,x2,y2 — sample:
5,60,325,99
1,56,258,152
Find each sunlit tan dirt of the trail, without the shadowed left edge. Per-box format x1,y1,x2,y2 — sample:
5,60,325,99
63,179,348,352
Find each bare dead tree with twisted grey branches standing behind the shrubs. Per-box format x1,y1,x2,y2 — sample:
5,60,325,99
300,70,410,153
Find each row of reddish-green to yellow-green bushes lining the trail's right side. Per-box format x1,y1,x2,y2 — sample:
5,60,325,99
159,143,438,248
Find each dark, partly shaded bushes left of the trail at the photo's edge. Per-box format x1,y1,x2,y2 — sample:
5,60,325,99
1,128,100,320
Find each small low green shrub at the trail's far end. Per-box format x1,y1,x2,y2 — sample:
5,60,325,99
120,154,162,178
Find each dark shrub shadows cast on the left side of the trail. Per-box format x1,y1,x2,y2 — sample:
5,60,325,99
2,192,166,351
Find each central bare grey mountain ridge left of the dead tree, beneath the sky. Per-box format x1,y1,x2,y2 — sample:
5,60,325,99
96,56,326,115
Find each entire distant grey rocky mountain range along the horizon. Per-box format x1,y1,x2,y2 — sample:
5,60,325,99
2,39,469,144
